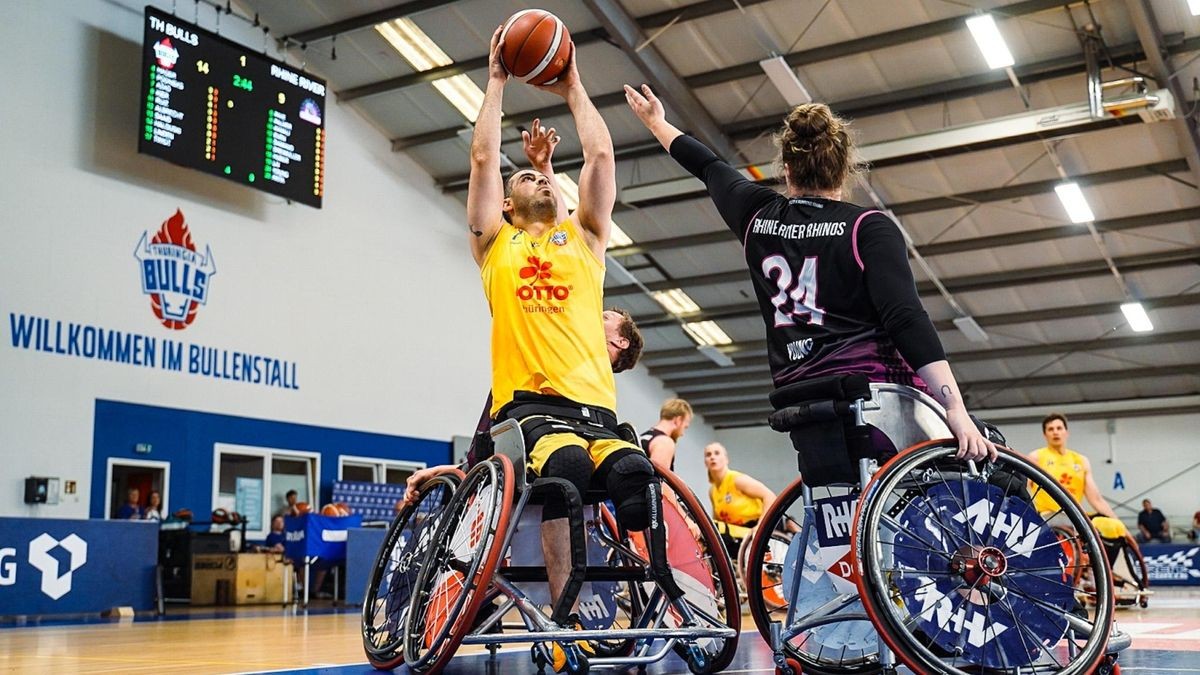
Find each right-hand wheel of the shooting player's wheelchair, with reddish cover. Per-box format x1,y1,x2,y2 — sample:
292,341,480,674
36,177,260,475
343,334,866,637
656,467,742,674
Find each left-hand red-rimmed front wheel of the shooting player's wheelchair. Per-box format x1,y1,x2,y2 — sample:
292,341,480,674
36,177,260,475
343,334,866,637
403,455,512,673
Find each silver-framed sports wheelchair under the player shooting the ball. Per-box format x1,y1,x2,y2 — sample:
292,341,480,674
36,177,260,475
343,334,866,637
362,410,742,674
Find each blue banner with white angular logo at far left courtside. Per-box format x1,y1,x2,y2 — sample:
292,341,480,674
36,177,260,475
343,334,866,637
0,518,158,616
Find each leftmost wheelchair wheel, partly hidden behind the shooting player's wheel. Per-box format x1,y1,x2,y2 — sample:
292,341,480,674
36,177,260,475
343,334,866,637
362,470,463,670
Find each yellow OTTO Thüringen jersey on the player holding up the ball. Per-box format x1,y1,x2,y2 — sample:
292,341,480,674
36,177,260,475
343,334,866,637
480,220,617,416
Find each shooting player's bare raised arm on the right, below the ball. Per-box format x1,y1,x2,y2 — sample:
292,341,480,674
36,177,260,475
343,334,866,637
541,47,617,259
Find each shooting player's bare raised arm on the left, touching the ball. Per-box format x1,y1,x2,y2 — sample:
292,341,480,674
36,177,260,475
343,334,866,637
467,28,509,264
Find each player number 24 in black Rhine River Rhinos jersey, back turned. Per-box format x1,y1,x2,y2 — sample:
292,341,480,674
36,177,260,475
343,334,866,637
625,84,996,459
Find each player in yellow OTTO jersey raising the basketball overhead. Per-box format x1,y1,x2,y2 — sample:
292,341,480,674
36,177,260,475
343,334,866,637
467,29,668,648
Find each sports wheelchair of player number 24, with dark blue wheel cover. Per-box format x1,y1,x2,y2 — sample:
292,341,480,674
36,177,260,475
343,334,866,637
746,376,1130,675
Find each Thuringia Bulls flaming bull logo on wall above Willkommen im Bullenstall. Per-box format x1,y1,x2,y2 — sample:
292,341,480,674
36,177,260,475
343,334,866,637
133,209,217,330
